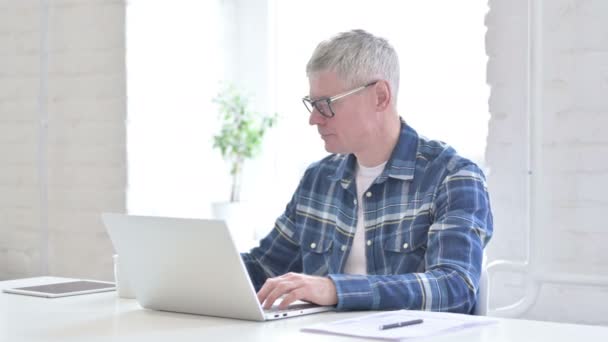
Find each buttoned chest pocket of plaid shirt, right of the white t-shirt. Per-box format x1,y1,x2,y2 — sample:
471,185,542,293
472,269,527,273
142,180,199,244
382,225,428,274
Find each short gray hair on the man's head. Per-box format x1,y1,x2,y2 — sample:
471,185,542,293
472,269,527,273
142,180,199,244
306,30,399,105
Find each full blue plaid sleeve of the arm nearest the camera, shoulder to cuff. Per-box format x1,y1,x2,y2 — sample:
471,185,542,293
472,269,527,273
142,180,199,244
329,164,493,313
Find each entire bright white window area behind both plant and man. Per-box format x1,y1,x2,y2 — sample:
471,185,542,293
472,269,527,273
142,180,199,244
127,0,489,240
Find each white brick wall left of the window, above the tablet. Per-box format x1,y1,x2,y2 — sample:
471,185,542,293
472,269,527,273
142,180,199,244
0,0,126,279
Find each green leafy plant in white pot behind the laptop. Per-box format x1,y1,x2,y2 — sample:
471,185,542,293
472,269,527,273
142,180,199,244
213,84,277,247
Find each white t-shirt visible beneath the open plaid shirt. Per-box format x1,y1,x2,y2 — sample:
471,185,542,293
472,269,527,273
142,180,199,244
344,162,386,274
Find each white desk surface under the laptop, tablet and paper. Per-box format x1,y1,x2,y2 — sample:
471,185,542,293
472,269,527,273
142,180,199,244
0,277,608,342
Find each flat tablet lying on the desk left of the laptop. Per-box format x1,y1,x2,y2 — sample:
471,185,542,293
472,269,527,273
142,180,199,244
3,280,116,298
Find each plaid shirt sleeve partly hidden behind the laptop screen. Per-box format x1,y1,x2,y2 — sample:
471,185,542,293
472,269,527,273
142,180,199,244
241,190,302,291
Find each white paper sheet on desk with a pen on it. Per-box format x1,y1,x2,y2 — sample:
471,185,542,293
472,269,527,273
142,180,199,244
302,310,498,340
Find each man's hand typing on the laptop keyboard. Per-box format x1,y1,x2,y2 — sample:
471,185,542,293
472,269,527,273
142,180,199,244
258,273,338,310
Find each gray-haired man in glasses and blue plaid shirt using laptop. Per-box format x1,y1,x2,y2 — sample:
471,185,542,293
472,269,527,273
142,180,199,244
242,30,492,313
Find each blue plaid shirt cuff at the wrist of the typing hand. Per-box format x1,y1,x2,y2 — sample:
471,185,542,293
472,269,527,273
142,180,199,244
328,274,379,311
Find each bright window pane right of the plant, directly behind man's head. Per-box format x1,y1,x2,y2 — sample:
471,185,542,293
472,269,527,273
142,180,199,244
270,0,490,218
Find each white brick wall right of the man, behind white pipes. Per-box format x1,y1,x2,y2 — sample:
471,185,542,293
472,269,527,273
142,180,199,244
486,0,608,324
